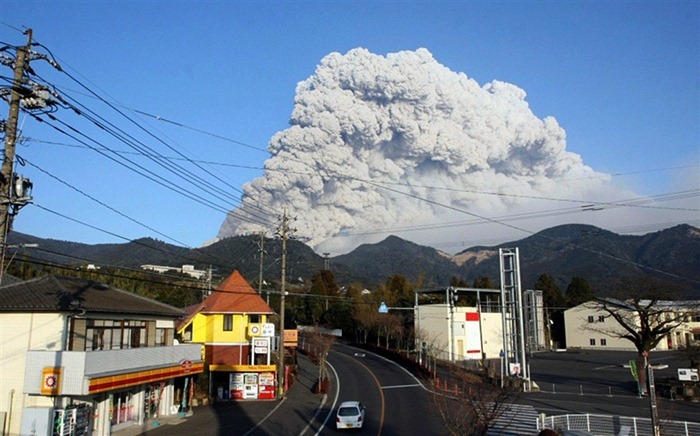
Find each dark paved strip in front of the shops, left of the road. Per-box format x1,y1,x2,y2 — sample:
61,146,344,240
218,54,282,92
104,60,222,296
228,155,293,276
112,353,327,436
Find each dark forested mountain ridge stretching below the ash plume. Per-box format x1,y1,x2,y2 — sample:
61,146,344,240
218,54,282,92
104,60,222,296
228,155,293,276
8,224,700,297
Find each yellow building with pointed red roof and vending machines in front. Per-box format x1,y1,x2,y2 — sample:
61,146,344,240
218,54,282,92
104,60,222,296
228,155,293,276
177,271,277,399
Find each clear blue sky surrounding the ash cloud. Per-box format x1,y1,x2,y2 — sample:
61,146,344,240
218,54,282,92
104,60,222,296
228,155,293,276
0,0,700,252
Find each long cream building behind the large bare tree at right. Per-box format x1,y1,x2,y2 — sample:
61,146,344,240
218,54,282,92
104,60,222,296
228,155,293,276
564,301,700,351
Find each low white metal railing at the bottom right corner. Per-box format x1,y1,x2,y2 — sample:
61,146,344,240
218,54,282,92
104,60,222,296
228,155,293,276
537,414,700,436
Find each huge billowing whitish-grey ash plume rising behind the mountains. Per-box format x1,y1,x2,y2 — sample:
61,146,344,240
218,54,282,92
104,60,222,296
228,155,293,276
218,49,605,254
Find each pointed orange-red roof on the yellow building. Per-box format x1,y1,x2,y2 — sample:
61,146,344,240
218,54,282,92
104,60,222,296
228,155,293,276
198,271,274,314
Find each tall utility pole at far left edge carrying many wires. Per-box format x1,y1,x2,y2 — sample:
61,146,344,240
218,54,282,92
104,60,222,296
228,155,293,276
0,29,32,277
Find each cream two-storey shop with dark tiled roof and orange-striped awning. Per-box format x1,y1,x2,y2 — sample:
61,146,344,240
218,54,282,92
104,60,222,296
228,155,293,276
0,275,204,435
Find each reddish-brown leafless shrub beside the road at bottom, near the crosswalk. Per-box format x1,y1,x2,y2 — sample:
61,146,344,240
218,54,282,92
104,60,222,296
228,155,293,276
434,367,520,436
